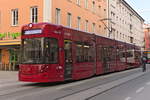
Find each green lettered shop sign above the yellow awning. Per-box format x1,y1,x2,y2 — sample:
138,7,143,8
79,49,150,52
0,32,21,39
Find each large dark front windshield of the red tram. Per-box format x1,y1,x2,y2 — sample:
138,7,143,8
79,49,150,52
21,38,44,64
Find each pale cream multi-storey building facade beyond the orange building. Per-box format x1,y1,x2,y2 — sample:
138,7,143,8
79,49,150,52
107,0,144,47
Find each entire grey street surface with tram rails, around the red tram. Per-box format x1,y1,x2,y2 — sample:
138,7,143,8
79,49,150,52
0,65,150,100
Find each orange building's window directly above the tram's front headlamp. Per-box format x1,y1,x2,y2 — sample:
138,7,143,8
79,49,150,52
30,7,38,23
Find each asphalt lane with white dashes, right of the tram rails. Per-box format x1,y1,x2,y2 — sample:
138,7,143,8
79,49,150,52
88,69,150,100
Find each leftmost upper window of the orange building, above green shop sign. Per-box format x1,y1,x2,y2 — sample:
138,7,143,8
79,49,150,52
11,9,18,26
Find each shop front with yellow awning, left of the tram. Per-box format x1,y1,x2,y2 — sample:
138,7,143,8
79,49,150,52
0,32,21,71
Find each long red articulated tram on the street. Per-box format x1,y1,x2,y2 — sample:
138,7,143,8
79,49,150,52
19,23,140,82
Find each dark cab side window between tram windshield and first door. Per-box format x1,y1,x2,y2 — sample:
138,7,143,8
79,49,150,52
45,38,58,64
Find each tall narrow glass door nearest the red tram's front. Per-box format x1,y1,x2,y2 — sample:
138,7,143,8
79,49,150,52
64,40,72,80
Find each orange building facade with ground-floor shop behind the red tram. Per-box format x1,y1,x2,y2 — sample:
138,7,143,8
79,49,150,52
0,0,108,70
